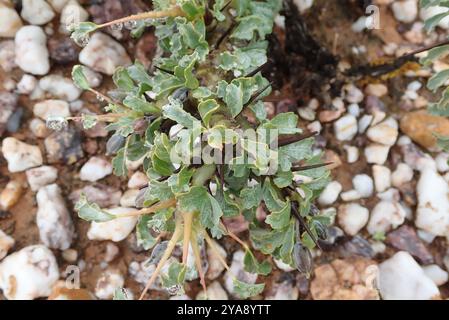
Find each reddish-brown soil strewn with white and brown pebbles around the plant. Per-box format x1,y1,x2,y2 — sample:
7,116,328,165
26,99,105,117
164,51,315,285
0,0,449,299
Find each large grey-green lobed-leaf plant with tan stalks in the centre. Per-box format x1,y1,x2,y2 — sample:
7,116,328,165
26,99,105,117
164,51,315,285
72,0,329,298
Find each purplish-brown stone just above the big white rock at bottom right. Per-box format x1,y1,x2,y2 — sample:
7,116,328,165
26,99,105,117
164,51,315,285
386,225,434,264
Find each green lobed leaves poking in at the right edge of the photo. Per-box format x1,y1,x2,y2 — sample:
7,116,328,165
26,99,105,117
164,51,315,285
420,0,449,151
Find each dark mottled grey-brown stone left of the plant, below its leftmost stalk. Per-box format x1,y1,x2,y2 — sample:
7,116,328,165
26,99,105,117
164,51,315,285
45,127,84,164
